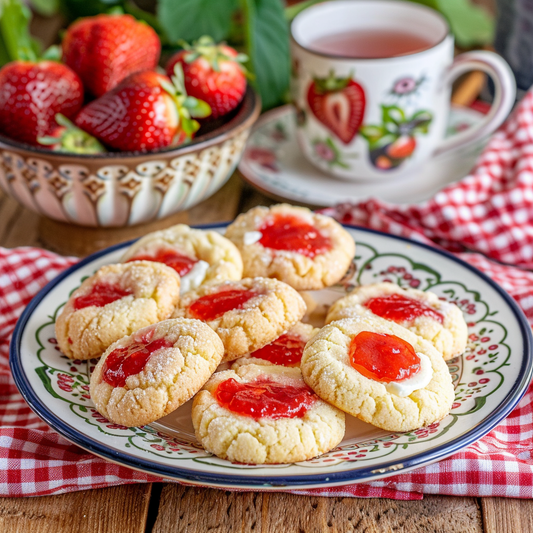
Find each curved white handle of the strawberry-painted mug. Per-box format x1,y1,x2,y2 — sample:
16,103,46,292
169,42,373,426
433,50,516,155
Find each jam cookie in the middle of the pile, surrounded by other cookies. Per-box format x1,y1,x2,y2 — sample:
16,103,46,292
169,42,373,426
173,278,305,361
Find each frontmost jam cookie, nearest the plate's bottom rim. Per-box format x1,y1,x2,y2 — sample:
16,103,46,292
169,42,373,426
192,364,345,464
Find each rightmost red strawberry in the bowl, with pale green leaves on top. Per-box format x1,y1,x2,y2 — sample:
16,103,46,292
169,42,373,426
166,36,248,118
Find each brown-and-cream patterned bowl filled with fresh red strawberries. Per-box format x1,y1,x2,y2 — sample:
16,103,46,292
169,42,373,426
0,6,261,227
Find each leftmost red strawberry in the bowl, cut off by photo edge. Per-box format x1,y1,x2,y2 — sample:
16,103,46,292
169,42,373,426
0,61,83,145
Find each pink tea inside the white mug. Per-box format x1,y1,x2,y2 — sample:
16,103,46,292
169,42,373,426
311,28,435,59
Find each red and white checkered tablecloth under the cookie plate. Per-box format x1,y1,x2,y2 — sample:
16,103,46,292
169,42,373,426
0,92,533,500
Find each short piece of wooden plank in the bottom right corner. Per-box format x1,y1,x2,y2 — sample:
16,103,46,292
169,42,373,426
481,498,533,533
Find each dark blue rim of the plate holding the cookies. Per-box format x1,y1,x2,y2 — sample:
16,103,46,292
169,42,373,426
9,223,533,489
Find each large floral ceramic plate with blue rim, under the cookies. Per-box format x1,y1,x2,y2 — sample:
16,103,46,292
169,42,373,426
10,225,533,490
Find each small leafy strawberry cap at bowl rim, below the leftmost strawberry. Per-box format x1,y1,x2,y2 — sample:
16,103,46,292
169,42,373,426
37,113,106,154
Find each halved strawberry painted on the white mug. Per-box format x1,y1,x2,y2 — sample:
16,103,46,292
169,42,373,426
307,72,365,144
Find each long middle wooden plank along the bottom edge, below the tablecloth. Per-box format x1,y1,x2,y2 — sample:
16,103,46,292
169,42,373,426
152,484,483,533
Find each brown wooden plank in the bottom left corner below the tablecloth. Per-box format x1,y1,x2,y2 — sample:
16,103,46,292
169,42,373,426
0,483,151,533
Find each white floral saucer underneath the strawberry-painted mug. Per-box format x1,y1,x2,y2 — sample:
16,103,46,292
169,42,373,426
239,106,485,207
